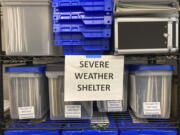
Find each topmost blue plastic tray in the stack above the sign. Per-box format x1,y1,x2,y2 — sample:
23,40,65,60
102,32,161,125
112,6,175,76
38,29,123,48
52,0,113,11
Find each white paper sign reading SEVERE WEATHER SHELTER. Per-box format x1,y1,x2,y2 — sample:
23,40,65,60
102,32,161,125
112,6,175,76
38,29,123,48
65,56,124,101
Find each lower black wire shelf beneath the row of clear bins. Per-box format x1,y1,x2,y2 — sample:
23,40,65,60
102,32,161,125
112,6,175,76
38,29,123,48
4,113,179,130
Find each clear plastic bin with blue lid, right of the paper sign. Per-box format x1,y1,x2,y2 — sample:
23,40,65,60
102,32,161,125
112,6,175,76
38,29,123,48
130,65,174,119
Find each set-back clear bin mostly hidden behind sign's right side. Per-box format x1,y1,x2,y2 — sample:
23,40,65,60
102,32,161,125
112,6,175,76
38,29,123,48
97,67,128,112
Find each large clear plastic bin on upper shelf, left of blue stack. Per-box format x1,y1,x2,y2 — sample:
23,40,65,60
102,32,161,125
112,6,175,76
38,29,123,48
0,0,59,56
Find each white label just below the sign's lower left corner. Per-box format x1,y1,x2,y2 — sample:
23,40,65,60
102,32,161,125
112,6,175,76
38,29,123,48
65,105,81,118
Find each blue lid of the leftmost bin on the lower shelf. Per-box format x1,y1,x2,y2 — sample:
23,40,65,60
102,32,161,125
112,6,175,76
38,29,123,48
6,65,46,73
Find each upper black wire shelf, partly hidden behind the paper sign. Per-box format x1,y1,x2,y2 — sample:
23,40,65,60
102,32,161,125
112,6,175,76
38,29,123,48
0,53,180,64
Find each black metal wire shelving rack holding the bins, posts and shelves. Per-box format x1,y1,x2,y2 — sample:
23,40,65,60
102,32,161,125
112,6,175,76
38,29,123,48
0,2,180,135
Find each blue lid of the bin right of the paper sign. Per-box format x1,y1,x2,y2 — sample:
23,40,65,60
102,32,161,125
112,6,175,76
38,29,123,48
129,65,174,71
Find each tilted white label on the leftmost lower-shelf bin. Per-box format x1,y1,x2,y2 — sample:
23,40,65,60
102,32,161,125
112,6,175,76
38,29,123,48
18,106,35,119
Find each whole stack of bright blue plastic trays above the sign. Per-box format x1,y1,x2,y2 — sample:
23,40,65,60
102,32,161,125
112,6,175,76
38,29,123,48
52,0,113,55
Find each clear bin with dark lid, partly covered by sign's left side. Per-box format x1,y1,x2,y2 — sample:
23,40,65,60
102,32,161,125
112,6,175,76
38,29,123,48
46,65,93,120
